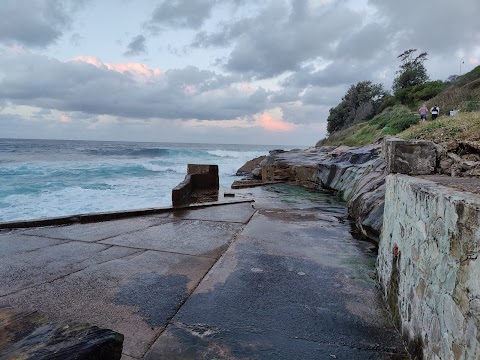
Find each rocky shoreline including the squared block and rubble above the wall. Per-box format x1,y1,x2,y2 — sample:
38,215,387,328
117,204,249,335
232,137,480,242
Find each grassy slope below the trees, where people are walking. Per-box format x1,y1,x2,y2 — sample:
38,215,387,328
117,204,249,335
316,66,480,146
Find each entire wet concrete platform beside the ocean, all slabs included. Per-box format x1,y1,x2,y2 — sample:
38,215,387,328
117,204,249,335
0,186,408,360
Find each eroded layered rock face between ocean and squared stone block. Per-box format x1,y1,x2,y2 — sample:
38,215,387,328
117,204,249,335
234,143,386,239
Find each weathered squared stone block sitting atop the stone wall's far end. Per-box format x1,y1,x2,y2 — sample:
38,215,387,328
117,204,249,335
384,138,437,175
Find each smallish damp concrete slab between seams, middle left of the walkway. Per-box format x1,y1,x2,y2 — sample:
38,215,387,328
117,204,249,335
100,219,242,258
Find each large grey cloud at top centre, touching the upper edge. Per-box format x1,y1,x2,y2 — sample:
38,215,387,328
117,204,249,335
192,0,361,78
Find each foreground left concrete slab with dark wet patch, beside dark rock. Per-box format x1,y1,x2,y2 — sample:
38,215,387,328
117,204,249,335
0,250,214,358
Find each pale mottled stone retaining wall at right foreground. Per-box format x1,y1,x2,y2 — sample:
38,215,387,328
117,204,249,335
377,175,480,359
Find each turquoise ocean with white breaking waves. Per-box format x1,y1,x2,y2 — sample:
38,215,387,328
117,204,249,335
0,139,294,222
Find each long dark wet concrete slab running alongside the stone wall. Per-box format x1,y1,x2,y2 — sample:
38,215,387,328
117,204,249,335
145,187,409,359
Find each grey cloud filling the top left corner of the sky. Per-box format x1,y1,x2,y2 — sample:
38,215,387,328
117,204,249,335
0,0,86,47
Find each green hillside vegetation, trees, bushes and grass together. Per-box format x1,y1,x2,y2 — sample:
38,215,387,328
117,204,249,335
316,49,480,146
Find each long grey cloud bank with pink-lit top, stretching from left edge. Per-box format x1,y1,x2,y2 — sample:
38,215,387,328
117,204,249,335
0,52,270,120
